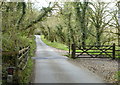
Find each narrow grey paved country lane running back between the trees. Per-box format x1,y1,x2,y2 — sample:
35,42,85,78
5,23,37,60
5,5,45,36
33,35,103,83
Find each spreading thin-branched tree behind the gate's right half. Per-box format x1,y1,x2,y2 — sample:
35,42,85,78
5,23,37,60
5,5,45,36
89,2,111,45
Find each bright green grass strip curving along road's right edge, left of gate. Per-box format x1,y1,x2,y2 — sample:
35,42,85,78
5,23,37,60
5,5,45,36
41,35,69,51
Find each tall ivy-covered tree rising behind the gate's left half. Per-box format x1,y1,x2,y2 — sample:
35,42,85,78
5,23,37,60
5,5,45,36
74,0,89,46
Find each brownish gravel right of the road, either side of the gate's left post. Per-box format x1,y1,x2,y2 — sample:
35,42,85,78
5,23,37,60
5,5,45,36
53,48,118,83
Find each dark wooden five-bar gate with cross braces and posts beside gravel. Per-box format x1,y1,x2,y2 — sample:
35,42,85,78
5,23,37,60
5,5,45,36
71,44,120,59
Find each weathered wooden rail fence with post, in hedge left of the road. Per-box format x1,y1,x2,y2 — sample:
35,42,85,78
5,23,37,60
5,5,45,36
2,46,30,82
